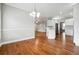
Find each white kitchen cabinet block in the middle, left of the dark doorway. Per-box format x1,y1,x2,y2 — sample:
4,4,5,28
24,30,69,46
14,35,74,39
46,20,56,39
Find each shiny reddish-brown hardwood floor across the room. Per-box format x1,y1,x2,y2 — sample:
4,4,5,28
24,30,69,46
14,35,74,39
0,32,79,55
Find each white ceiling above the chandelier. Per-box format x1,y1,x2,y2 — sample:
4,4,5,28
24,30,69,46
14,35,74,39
6,3,72,17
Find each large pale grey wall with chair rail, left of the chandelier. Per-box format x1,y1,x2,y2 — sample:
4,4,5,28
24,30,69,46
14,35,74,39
2,5,35,43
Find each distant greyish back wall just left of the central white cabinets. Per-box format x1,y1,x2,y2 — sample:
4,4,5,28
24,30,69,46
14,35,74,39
36,16,47,32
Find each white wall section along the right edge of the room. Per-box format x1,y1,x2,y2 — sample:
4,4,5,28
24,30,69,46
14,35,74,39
73,4,79,46
